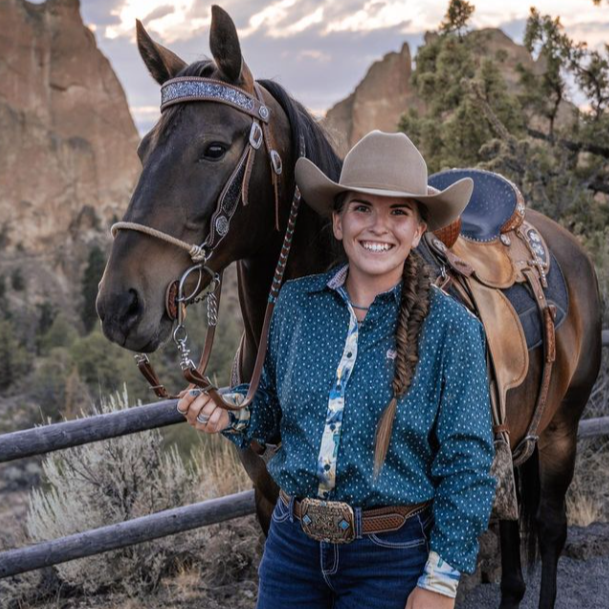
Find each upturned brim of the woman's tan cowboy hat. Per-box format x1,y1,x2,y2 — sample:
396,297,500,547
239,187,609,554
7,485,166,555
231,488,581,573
295,157,474,231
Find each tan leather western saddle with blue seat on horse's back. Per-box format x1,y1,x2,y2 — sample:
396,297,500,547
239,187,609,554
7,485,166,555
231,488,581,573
419,169,564,466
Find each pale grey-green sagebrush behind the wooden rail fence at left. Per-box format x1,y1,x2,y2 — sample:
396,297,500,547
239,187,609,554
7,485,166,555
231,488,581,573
0,390,251,606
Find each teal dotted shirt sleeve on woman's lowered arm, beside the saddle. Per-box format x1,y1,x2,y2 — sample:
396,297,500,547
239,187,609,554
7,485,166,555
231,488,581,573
426,312,495,576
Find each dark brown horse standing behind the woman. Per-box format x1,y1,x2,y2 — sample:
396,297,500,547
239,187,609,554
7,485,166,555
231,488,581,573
97,6,601,609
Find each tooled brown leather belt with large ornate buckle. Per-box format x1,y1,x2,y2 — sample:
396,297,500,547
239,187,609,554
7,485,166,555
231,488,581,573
279,489,432,543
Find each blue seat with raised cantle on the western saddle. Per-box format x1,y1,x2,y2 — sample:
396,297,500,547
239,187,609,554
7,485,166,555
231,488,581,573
428,169,518,241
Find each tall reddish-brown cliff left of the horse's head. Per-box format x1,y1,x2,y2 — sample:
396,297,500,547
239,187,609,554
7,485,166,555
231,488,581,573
0,0,139,314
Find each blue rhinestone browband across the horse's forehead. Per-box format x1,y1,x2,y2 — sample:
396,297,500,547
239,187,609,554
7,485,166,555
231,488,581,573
161,76,270,123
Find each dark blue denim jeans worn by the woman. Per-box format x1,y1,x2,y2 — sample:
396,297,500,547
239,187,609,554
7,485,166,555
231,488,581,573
256,499,433,609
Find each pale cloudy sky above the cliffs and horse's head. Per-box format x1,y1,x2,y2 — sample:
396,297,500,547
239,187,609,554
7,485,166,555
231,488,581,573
58,0,609,134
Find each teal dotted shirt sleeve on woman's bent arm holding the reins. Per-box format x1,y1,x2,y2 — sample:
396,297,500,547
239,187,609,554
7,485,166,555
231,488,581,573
220,288,285,448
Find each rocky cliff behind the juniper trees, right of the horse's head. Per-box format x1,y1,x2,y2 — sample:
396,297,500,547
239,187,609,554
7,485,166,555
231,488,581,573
324,28,570,155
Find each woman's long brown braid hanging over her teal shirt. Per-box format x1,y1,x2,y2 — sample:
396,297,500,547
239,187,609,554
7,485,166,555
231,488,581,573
374,250,431,478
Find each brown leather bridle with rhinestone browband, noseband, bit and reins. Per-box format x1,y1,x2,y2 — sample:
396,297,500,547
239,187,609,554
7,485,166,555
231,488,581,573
111,76,305,410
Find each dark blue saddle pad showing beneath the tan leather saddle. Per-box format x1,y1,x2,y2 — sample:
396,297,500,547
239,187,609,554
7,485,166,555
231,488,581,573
416,239,569,351
